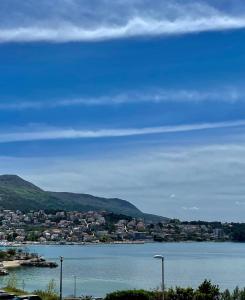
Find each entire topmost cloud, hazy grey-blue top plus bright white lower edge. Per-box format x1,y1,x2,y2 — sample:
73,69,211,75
0,0,245,42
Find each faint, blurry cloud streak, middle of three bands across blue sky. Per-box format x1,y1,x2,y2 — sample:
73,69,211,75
0,87,245,110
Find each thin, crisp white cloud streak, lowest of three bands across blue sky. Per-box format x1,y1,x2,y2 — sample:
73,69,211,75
0,120,245,143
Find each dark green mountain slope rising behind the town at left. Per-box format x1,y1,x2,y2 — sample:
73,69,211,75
0,175,167,222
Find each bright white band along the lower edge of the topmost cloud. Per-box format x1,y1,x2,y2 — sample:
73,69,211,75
0,15,245,42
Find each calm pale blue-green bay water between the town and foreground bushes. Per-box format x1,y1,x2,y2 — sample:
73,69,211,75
1,243,245,296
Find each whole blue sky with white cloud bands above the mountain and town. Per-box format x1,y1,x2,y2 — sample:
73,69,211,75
0,0,245,222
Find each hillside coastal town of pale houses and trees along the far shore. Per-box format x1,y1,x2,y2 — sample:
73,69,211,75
0,210,241,245
